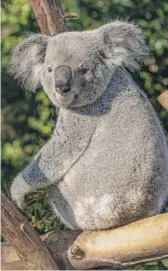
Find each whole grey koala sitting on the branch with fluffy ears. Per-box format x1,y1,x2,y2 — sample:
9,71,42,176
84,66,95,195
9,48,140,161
9,21,168,230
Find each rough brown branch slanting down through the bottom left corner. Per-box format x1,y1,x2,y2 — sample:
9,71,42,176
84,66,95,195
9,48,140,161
1,194,58,270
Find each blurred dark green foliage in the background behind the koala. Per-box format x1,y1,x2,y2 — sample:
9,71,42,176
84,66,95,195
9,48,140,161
1,0,168,270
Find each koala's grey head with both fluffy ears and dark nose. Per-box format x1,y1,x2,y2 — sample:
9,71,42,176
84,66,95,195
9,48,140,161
9,21,148,107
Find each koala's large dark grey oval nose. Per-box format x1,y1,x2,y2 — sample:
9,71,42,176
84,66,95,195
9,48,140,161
55,65,72,94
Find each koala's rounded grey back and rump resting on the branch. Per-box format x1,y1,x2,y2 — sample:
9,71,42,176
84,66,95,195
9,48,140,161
50,73,168,230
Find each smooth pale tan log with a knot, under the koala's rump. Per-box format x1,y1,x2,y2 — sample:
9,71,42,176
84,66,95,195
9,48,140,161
68,213,168,269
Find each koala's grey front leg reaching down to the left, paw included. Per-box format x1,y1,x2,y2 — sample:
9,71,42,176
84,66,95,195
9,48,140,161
11,127,94,207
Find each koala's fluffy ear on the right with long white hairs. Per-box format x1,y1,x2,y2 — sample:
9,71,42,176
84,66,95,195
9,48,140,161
99,21,148,71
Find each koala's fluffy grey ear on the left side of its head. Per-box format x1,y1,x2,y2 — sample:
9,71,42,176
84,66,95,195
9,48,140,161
8,34,49,91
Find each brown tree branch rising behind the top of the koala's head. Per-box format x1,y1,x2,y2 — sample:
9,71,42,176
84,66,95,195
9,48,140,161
30,0,66,36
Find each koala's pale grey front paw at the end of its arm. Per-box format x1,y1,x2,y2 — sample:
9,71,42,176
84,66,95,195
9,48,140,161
10,176,28,209
